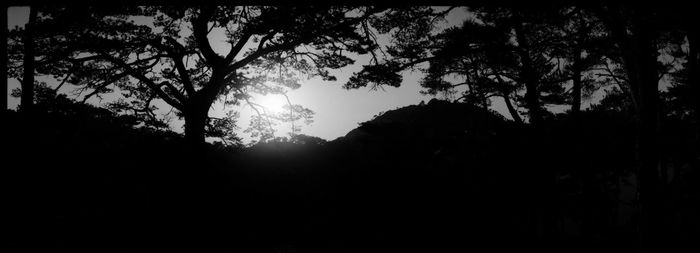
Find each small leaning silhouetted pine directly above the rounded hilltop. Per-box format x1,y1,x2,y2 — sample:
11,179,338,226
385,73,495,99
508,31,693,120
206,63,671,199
421,20,522,123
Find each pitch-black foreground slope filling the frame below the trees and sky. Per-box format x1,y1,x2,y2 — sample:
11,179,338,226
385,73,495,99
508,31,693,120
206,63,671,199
3,98,698,252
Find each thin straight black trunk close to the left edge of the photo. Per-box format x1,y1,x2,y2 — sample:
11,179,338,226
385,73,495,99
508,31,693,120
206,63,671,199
20,7,37,112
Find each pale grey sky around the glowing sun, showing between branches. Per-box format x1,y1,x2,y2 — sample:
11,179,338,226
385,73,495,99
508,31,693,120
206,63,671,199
8,7,510,143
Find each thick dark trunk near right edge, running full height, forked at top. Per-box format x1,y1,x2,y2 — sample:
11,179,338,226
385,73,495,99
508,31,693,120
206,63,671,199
613,7,663,252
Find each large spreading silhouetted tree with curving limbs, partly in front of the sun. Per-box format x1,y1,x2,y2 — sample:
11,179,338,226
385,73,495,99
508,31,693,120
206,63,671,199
13,6,382,143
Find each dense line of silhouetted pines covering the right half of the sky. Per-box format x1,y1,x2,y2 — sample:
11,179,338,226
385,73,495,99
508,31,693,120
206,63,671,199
346,3,700,252
